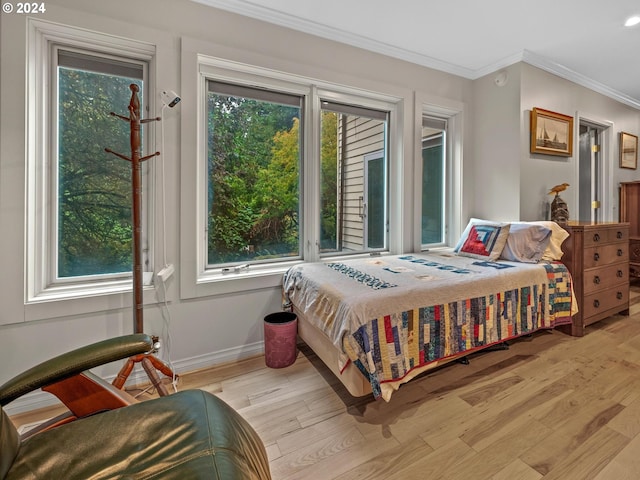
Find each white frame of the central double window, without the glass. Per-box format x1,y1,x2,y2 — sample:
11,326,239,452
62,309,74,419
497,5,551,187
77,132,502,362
180,52,404,298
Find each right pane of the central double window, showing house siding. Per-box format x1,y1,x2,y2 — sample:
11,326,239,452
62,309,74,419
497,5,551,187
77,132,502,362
320,101,388,255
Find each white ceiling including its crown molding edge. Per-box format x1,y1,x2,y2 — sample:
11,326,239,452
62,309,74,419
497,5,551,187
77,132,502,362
194,0,640,109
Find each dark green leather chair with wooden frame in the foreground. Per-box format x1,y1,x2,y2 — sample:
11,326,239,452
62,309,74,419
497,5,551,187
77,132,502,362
0,334,271,480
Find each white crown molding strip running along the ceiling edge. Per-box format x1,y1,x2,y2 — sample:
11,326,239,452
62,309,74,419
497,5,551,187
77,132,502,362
192,0,640,110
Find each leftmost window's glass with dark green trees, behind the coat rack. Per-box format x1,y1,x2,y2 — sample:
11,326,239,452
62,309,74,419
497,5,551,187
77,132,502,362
53,49,144,278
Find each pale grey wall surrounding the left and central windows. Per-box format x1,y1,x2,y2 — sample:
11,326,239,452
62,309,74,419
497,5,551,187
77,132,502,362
0,0,472,411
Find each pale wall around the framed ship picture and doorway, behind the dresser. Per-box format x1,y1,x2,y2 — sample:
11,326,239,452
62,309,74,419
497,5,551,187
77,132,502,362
465,63,640,221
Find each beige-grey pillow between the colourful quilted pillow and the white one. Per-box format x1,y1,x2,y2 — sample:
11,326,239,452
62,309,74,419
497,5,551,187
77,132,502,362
500,223,551,263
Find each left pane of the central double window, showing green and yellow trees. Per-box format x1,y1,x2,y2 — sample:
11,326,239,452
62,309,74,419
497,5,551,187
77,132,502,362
207,81,303,267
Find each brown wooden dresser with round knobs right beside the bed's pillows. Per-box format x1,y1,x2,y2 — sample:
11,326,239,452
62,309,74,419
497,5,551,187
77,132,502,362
562,222,629,336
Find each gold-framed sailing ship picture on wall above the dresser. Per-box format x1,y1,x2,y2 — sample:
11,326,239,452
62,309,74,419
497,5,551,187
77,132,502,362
530,108,573,157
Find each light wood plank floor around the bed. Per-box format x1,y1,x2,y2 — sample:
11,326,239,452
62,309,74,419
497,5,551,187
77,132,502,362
8,284,640,480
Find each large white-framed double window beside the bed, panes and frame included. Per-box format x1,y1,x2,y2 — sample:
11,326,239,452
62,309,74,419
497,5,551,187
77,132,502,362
191,55,400,284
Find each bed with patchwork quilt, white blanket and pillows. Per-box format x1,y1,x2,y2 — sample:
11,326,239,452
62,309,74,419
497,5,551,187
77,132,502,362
283,219,577,401
